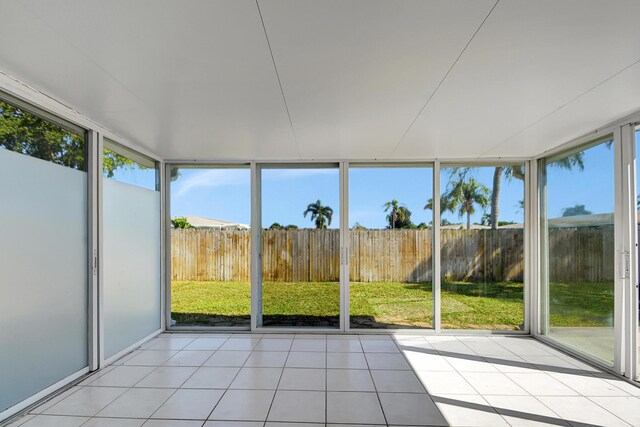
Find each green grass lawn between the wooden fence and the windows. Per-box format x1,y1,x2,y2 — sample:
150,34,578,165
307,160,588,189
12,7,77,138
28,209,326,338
171,281,613,330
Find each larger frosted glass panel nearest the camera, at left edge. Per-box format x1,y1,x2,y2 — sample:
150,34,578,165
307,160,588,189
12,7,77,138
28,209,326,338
0,149,88,412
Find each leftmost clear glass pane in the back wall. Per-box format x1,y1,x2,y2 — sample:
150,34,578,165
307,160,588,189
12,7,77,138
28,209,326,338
171,167,251,327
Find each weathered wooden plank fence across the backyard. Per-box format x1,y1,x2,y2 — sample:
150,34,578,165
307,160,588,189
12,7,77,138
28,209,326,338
171,227,614,283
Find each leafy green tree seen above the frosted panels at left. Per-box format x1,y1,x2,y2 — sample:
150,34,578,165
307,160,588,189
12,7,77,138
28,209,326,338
0,101,136,178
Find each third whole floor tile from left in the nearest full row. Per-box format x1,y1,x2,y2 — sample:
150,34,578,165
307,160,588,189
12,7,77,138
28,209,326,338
151,389,224,420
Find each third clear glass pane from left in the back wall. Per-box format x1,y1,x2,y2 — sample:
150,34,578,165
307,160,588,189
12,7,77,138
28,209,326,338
349,167,433,329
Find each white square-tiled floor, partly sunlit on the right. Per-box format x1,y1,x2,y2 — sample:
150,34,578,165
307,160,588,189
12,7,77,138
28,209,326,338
6,334,640,427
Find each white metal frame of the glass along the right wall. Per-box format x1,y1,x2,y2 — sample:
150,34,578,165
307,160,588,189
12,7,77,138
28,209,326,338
528,112,640,380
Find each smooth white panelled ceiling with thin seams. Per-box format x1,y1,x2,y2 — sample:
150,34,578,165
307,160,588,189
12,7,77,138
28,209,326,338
0,0,640,160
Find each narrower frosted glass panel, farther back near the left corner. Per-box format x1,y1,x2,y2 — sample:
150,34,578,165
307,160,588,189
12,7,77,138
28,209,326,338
103,179,161,358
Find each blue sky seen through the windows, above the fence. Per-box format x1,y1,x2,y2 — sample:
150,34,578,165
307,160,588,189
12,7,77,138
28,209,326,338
109,135,624,228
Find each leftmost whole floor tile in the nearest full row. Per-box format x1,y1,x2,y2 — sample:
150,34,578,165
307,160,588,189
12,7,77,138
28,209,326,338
43,387,126,416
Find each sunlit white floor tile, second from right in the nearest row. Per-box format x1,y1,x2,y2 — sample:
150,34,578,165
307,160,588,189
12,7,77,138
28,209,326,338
538,396,629,427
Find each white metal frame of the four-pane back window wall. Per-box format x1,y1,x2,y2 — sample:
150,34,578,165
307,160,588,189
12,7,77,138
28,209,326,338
163,158,535,335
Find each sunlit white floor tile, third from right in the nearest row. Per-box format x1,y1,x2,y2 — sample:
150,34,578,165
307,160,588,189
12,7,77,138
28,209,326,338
485,396,569,427
